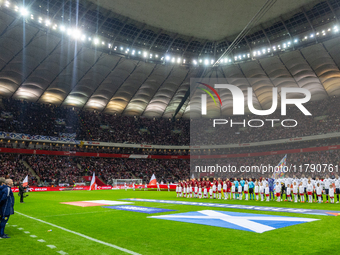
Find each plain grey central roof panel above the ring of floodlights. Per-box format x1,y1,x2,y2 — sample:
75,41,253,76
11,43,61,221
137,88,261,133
91,0,315,40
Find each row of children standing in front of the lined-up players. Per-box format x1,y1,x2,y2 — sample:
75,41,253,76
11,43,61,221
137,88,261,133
176,180,334,203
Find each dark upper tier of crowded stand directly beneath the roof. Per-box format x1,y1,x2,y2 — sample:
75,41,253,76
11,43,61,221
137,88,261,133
0,97,340,145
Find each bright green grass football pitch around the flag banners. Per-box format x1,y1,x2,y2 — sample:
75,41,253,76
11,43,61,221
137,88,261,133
0,190,340,255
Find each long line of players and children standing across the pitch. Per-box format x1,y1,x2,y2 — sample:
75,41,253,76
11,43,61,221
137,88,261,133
176,175,340,203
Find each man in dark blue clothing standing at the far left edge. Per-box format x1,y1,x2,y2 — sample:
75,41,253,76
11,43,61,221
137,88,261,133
0,179,14,238
